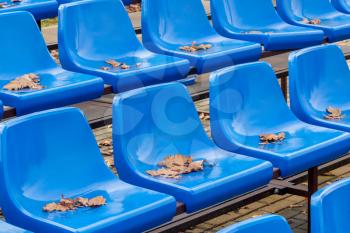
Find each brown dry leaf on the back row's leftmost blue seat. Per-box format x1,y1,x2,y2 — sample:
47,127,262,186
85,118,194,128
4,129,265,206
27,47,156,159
3,74,44,91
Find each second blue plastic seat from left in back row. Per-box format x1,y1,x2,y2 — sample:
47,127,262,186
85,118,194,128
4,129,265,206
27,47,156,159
59,0,189,92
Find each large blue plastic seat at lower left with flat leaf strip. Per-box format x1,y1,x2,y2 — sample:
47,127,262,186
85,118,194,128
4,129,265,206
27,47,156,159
0,108,176,233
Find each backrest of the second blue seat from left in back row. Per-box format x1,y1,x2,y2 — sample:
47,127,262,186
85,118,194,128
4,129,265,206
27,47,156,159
58,0,142,62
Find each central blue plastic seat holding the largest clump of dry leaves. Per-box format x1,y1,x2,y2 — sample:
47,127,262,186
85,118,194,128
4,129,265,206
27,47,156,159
113,83,272,212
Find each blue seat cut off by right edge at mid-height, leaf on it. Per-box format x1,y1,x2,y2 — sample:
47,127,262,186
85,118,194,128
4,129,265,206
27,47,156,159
289,45,350,132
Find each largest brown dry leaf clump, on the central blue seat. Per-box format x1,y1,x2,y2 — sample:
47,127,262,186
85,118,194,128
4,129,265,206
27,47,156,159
146,154,205,179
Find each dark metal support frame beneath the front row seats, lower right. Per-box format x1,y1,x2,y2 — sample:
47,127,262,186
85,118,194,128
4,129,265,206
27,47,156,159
148,155,350,233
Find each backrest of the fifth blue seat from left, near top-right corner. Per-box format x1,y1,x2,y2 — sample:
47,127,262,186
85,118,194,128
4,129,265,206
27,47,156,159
276,0,340,21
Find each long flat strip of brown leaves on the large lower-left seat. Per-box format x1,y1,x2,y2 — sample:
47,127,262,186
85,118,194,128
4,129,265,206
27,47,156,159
43,196,106,212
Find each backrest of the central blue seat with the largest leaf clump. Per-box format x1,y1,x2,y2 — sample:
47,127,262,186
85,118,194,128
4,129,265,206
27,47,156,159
113,83,213,174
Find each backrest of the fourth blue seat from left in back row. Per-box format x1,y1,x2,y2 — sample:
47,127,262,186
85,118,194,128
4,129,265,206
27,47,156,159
210,0,283,32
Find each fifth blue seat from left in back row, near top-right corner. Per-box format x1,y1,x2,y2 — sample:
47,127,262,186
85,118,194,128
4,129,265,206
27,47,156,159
276,0,350,42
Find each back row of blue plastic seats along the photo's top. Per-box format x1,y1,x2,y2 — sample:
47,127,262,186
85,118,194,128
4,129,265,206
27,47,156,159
0,0,350,115
